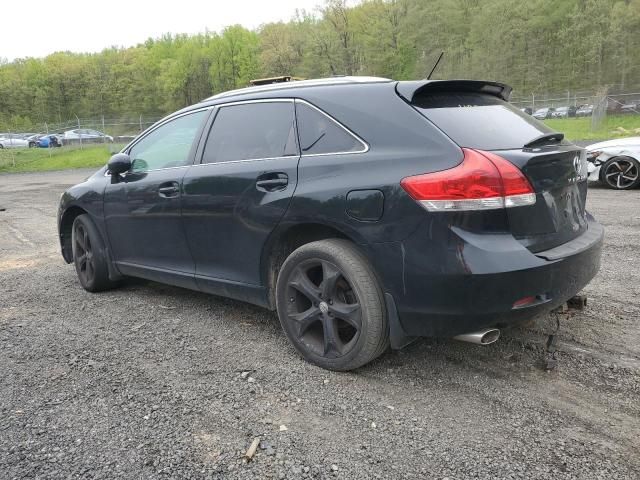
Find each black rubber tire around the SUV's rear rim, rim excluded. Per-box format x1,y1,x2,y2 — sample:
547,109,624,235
276,241,385,370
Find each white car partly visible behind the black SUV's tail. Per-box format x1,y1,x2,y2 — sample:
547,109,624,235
585,137,640,190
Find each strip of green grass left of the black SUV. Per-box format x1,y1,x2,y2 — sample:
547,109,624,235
0,145,118,173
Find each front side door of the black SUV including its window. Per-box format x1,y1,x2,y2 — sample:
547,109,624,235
104,110,210,288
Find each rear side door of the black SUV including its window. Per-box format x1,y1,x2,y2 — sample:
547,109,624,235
182,99,300,290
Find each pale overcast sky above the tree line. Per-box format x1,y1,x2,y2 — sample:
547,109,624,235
0,0,324,61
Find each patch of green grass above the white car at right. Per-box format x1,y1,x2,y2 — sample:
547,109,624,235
544,115,640,140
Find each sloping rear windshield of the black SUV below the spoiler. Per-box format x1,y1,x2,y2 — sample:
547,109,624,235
413,92,553,150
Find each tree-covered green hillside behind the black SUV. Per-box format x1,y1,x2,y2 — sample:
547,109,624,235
0,0,640,131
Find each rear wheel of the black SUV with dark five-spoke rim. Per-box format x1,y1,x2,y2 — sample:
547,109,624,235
276,239,389,371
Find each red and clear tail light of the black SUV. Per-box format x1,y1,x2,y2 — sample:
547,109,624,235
400,148,536,212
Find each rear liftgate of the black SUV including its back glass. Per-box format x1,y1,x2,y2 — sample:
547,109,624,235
411,89,587,252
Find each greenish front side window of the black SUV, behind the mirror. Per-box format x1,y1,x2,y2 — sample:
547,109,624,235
129,110,209,172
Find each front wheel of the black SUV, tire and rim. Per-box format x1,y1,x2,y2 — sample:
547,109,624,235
71,214,116,292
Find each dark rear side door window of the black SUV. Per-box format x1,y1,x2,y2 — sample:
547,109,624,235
202,102,298,163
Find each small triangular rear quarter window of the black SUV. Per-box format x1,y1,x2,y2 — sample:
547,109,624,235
296,102,366,155
